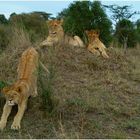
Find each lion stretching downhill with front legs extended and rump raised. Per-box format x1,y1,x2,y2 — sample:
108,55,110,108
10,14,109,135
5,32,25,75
0,47,39,130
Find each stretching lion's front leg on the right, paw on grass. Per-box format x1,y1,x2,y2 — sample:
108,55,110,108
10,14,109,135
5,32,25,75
11,100,27,130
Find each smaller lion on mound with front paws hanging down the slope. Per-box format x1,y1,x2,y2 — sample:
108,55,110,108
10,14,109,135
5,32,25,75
85,30,109,58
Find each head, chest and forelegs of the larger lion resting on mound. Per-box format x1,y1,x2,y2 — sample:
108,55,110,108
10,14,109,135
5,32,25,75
41,20,64,47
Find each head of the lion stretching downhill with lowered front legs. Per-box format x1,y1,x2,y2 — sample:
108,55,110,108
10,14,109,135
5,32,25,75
2,87,22,106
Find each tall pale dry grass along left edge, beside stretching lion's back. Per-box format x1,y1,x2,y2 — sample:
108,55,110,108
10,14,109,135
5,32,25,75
0,27,31,83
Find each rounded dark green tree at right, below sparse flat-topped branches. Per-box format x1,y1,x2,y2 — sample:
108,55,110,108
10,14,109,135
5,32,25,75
115,19,137,50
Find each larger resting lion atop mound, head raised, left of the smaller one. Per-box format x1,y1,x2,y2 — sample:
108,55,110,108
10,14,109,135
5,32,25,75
40,20,84,47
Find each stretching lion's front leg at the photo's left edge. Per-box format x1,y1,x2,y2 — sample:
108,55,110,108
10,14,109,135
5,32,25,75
0,103,12,130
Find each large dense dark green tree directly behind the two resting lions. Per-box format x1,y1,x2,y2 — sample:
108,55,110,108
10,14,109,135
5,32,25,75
57,1,112,45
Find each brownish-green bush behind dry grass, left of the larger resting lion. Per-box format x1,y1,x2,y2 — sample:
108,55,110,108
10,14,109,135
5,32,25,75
9,13,48,42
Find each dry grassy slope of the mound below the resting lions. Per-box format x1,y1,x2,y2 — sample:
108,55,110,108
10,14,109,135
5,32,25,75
0,44,140,138
